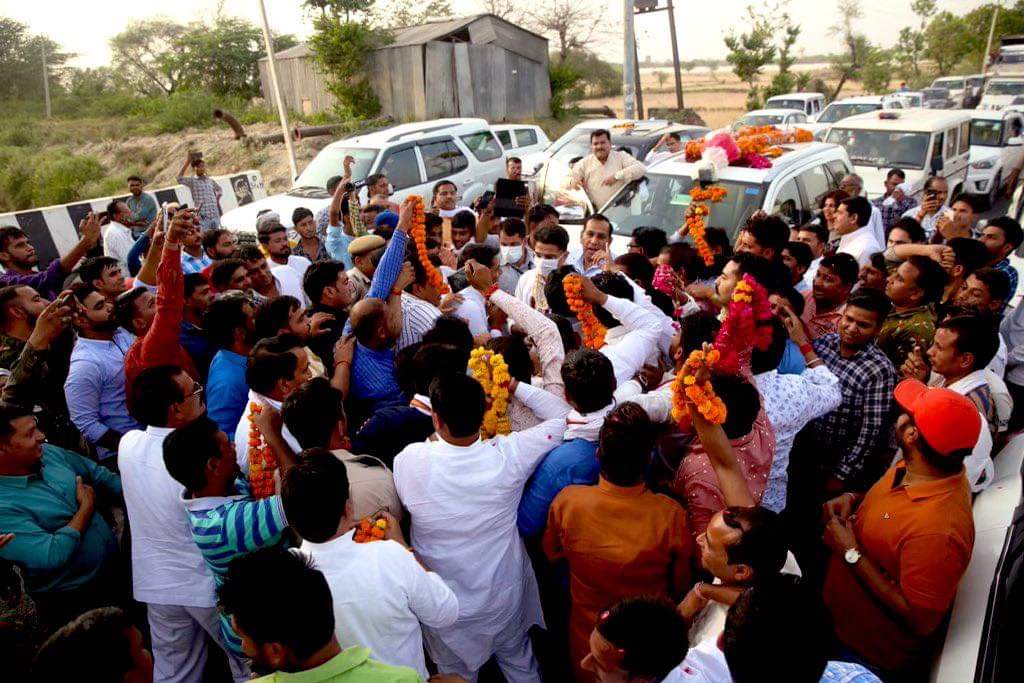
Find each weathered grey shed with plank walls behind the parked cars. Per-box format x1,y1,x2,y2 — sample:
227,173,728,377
259,14,551,121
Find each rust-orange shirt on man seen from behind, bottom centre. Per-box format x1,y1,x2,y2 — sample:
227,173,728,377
543,477,693,680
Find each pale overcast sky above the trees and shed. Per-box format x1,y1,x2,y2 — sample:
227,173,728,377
0,0,984,67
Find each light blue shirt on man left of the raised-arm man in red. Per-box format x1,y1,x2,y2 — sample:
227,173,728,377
65,328,141,458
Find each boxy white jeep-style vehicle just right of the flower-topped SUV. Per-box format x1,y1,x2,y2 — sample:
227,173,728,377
825,110,971,198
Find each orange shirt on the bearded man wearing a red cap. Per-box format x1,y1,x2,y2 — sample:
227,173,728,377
824,461,974,671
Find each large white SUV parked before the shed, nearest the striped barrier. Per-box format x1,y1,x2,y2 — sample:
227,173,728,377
220,119,505,232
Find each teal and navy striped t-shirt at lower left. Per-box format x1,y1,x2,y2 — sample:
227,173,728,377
184,486,288,655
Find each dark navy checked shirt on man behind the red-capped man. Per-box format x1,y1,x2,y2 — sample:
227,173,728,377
807,332,897,481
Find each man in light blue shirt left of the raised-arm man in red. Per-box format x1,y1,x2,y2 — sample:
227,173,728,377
65,283,139,459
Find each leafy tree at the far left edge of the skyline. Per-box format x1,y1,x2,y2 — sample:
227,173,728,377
0,17,71,100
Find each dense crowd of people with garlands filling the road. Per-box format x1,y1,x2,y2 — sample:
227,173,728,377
0,131,1024,683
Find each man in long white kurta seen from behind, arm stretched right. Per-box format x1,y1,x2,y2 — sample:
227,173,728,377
394,374,565,683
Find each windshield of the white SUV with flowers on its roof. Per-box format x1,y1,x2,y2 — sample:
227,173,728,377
604,173,764,238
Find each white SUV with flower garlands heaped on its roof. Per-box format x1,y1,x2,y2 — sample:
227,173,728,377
556,142,852,254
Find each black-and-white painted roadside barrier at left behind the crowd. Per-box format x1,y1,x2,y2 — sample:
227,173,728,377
0,170,266,267
